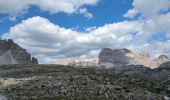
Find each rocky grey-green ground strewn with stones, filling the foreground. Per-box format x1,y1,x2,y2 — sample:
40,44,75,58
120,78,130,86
0,64,170,100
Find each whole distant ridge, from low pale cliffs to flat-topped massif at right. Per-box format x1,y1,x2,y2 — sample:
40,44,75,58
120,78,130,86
56,48,169,69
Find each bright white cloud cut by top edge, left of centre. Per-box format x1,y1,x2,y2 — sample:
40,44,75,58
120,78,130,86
34,0,99,13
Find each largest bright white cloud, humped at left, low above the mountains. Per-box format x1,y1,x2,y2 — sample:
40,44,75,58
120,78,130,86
2,16,137,63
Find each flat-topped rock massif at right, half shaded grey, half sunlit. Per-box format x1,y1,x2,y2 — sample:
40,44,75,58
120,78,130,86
98,48,168,68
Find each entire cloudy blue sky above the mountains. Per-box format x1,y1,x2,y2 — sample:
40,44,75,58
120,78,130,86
0,0,170,63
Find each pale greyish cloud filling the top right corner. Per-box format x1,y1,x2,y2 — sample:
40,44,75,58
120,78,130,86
125,0,170,18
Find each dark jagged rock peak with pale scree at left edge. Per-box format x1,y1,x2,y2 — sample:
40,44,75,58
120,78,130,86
0,39,38,64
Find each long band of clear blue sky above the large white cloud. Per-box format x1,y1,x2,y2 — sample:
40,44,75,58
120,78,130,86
0,0,132,34
